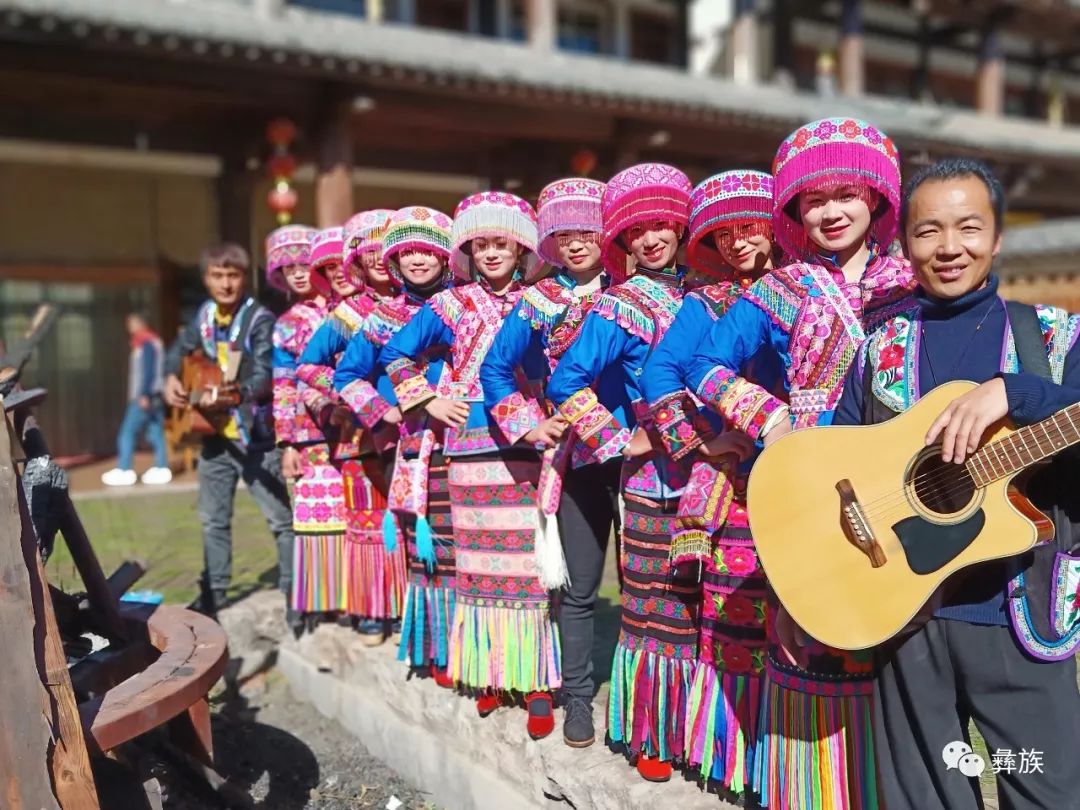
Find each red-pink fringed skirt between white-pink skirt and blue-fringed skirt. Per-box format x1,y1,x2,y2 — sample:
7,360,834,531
339,455,405,619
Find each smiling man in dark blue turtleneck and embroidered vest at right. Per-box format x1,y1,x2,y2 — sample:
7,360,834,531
825,160,1080,810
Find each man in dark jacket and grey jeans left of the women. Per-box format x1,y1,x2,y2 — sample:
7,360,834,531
164,244,293,612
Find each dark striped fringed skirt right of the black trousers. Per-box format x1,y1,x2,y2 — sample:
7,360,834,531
608,488,701,760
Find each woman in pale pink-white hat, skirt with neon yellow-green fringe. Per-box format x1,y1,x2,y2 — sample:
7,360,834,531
381,191,559,739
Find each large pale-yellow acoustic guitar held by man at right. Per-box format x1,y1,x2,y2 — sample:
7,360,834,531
747,382,1080,649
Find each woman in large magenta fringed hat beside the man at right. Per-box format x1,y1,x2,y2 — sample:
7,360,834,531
686,119,914,810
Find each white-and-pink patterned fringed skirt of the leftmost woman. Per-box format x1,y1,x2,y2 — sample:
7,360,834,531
291,444,346,613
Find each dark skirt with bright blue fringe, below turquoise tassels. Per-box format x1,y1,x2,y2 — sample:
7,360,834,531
397,450,455,669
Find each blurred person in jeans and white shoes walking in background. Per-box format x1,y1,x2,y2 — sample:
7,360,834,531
102,312,173,487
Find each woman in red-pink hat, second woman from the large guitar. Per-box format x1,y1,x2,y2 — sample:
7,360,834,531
643,170,784,795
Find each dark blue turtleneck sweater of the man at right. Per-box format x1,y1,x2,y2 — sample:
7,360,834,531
833,275,1080,624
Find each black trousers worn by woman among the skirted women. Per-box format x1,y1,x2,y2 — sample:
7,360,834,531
558,460,622,700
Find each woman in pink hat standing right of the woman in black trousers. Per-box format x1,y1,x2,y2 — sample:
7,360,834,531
548,163,700,781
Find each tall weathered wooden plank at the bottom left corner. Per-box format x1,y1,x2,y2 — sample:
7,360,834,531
0,418,99,810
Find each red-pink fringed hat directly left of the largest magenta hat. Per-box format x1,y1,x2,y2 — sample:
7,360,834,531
686,168,772,274
